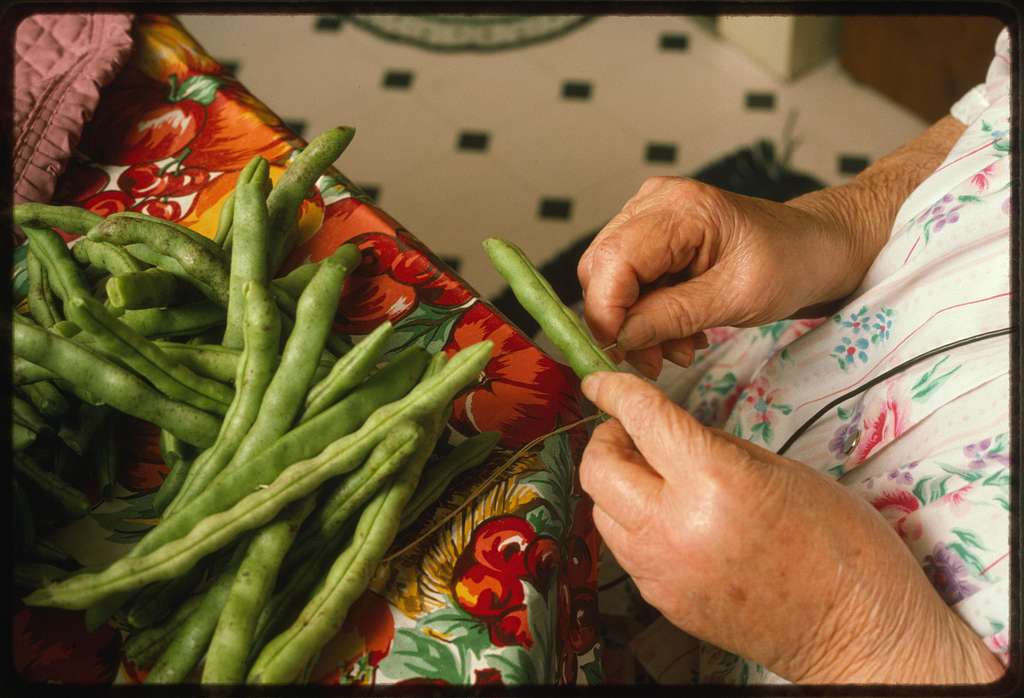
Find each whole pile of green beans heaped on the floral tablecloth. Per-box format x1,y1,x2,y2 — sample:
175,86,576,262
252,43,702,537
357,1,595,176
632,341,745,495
12,128,498,684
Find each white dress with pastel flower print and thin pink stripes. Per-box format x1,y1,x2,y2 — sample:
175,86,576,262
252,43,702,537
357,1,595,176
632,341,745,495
660,31,1012,684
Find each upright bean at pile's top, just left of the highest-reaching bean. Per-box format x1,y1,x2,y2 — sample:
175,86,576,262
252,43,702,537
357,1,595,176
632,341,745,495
223,156,270,349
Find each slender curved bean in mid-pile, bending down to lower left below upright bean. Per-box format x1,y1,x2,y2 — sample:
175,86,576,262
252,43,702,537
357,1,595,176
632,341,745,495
164,281,281,516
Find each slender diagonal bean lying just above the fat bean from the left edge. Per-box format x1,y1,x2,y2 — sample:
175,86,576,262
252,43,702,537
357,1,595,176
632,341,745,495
67,298,233,415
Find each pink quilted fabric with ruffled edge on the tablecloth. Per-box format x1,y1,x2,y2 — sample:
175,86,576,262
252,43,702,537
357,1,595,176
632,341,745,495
13,13,132,214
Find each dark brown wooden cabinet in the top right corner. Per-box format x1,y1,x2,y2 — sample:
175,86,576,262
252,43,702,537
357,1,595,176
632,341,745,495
840,15,1004,121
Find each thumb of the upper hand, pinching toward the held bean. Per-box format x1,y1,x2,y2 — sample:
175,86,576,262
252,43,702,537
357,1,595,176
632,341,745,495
616,267,729,351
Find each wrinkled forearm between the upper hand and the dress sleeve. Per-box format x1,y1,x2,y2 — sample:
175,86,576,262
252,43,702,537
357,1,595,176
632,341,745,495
787,116,966,316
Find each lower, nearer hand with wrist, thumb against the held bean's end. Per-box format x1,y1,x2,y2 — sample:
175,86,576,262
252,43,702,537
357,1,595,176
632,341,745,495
580,373,1005,684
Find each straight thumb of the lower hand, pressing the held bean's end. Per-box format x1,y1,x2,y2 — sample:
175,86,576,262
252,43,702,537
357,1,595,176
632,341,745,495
583,372,716,481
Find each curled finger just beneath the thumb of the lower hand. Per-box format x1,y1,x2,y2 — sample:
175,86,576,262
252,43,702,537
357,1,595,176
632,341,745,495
580,420,665,530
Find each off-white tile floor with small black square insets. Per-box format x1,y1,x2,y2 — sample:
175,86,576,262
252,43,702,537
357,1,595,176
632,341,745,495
180,14,925,296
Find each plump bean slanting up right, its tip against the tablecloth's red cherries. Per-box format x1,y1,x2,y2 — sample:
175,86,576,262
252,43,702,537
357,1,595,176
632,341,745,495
221,241,354,470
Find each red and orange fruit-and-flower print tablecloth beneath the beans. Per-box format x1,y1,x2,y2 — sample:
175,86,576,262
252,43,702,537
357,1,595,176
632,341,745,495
12,15,600,685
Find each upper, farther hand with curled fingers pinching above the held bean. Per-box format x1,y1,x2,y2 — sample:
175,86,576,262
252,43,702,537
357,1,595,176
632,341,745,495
578,177,888,378
